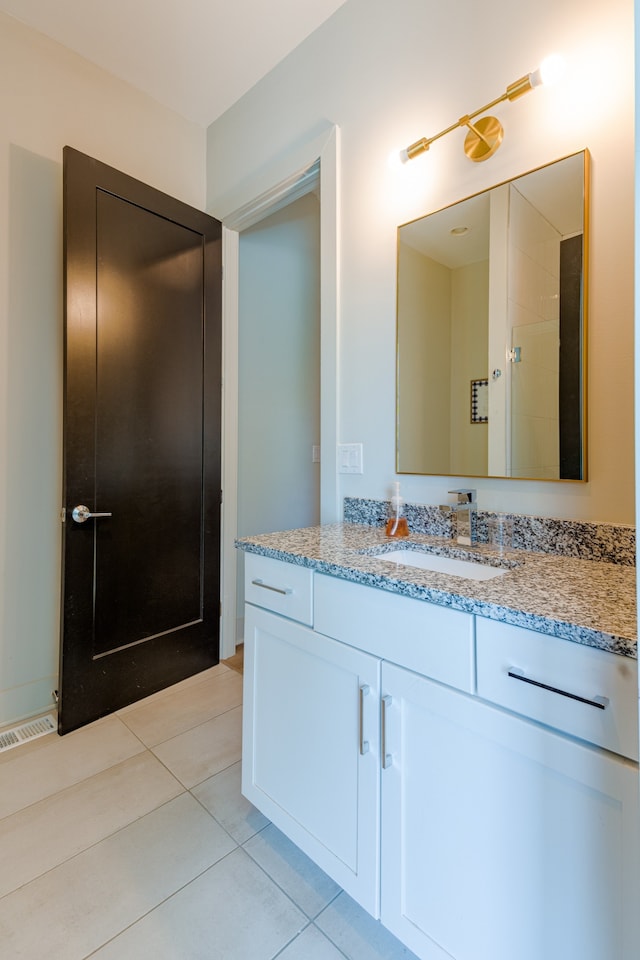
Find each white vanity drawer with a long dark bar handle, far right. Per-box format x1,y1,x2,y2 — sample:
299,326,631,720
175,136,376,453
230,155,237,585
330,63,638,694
476,617,638,760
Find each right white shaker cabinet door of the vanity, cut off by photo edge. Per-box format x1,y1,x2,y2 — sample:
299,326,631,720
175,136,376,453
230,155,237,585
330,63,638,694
381,664,640,960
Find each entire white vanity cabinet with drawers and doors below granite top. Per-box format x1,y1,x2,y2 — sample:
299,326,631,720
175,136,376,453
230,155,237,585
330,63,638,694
243,555,640,960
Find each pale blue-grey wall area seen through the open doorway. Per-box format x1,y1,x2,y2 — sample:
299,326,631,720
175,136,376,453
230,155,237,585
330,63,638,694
236,191,320,643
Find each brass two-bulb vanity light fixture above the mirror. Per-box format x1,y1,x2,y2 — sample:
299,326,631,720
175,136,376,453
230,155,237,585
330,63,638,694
400,54,562,163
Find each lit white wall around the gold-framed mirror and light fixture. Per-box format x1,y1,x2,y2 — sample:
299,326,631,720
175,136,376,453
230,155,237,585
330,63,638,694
207,0,634,523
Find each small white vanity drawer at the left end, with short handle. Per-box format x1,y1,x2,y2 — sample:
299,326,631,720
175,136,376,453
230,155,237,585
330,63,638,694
244,553,313,626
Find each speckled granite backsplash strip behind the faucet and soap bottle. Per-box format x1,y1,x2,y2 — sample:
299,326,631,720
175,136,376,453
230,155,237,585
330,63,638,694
344,497,636,565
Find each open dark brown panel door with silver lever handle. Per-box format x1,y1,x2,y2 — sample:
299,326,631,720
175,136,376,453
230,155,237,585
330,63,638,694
59,147,221,733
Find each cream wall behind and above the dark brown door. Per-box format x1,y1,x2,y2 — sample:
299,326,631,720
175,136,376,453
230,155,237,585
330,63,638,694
0,15,205,724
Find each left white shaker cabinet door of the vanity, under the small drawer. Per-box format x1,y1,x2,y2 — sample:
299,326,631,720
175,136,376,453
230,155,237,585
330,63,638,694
242,604,380,917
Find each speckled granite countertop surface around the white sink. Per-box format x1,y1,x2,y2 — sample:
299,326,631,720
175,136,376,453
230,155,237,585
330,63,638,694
236,523,637,658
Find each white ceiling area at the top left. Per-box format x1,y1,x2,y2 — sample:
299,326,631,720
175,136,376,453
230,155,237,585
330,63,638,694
0,0,345,126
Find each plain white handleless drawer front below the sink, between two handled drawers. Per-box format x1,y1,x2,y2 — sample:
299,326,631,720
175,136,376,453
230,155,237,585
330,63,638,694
314,574,475,693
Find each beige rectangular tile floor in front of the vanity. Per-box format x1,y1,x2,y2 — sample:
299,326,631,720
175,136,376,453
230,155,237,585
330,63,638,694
0,663,414,960
